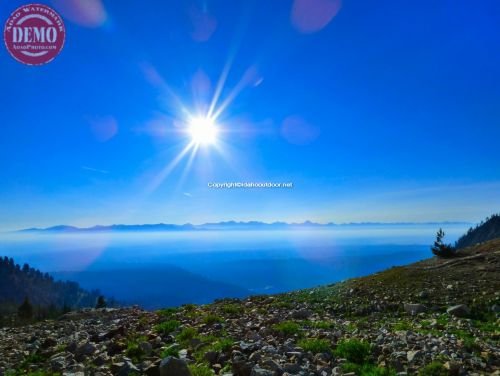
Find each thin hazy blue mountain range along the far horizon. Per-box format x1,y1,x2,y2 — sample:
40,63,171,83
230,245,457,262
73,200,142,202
17,221,470,233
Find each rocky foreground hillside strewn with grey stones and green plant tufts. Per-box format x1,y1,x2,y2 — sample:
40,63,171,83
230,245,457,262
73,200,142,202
0,240,500,376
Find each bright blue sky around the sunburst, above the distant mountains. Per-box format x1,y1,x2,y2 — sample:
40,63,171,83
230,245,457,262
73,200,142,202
0,0,500,230
